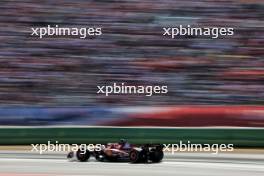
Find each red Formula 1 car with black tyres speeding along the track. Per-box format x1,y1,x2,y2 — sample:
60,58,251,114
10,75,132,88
67,140,163,163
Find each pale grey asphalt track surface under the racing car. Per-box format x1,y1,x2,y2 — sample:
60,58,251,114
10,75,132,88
0,151,264,176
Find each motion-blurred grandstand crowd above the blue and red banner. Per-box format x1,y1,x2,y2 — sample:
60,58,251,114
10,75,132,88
0,0,264,106
